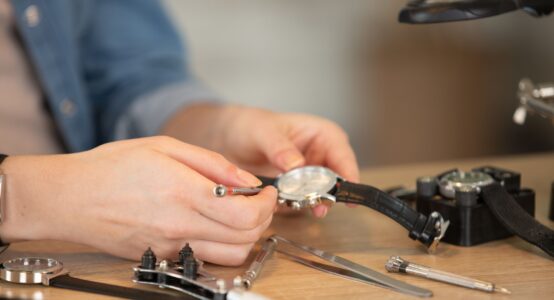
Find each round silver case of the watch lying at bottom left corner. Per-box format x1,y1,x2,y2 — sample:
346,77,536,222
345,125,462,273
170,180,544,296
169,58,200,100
0,257,68,286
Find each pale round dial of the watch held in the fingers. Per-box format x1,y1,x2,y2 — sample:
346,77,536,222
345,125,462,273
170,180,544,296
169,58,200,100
277,166,337,196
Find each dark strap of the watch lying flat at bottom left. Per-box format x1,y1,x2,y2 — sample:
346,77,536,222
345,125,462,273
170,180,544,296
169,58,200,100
50,274,188,300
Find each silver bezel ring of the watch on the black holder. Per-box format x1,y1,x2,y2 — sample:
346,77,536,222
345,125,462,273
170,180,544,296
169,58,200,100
437,170,495,199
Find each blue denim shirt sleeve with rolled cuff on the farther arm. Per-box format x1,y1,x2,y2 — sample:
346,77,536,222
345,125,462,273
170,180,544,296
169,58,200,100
80,0,218,143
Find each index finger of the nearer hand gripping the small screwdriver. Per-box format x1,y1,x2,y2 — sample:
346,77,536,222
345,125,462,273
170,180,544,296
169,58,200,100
151,137,261,186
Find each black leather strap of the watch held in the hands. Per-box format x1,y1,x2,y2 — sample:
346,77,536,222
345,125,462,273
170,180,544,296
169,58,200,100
335,181,438,246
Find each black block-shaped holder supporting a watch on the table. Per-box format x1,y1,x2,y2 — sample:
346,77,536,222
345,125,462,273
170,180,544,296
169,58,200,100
415,167,535,246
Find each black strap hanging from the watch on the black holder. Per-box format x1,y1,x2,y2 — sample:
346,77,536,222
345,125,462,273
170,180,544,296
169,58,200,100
482,184,554,257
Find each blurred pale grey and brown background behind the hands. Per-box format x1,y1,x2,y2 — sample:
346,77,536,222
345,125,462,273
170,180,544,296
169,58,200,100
166,0,554,166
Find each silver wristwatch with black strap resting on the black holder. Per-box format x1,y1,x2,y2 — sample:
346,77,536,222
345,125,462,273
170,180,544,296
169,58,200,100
437,167,554,256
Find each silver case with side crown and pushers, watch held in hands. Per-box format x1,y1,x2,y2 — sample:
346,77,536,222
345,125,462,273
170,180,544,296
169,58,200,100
275,166,344,210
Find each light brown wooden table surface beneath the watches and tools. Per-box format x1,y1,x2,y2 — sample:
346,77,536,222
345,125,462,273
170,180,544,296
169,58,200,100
0,153,554,299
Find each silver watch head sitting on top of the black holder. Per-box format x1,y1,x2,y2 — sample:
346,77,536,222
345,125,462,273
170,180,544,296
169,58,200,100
439,171,494,198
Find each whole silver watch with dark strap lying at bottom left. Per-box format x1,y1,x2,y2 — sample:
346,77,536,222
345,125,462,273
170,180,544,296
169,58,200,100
0,257,185,300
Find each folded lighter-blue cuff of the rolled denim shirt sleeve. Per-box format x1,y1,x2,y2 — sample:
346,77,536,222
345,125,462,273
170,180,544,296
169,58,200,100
113,81,222,140
